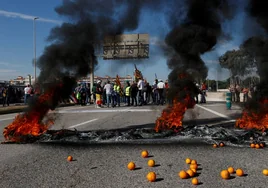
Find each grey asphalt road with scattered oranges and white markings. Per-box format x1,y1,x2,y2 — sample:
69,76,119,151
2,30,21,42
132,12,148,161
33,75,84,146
0,102,268,188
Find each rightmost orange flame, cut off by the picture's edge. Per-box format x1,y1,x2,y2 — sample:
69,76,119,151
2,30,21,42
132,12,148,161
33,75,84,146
235,99,268,131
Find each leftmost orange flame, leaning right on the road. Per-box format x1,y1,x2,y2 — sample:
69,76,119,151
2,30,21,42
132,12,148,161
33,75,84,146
3,88,57,142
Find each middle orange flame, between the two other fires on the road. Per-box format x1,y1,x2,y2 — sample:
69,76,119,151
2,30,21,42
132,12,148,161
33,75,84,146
155,95,195,132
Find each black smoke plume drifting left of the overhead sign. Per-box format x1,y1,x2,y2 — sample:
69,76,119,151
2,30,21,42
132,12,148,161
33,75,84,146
37,0,164,106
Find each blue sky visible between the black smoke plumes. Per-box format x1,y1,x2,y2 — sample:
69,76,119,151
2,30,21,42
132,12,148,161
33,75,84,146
0,0,252,82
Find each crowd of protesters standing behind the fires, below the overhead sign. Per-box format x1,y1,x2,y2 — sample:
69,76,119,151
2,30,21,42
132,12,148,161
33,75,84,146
72,79,168,108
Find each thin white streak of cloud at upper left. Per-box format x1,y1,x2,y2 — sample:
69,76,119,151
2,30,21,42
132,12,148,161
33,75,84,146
0,10,62,24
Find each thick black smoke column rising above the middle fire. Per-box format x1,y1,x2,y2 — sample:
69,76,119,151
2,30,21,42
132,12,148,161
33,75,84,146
166,0,231,100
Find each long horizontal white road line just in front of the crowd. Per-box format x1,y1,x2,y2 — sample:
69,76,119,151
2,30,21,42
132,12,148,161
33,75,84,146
56,109,159,114
